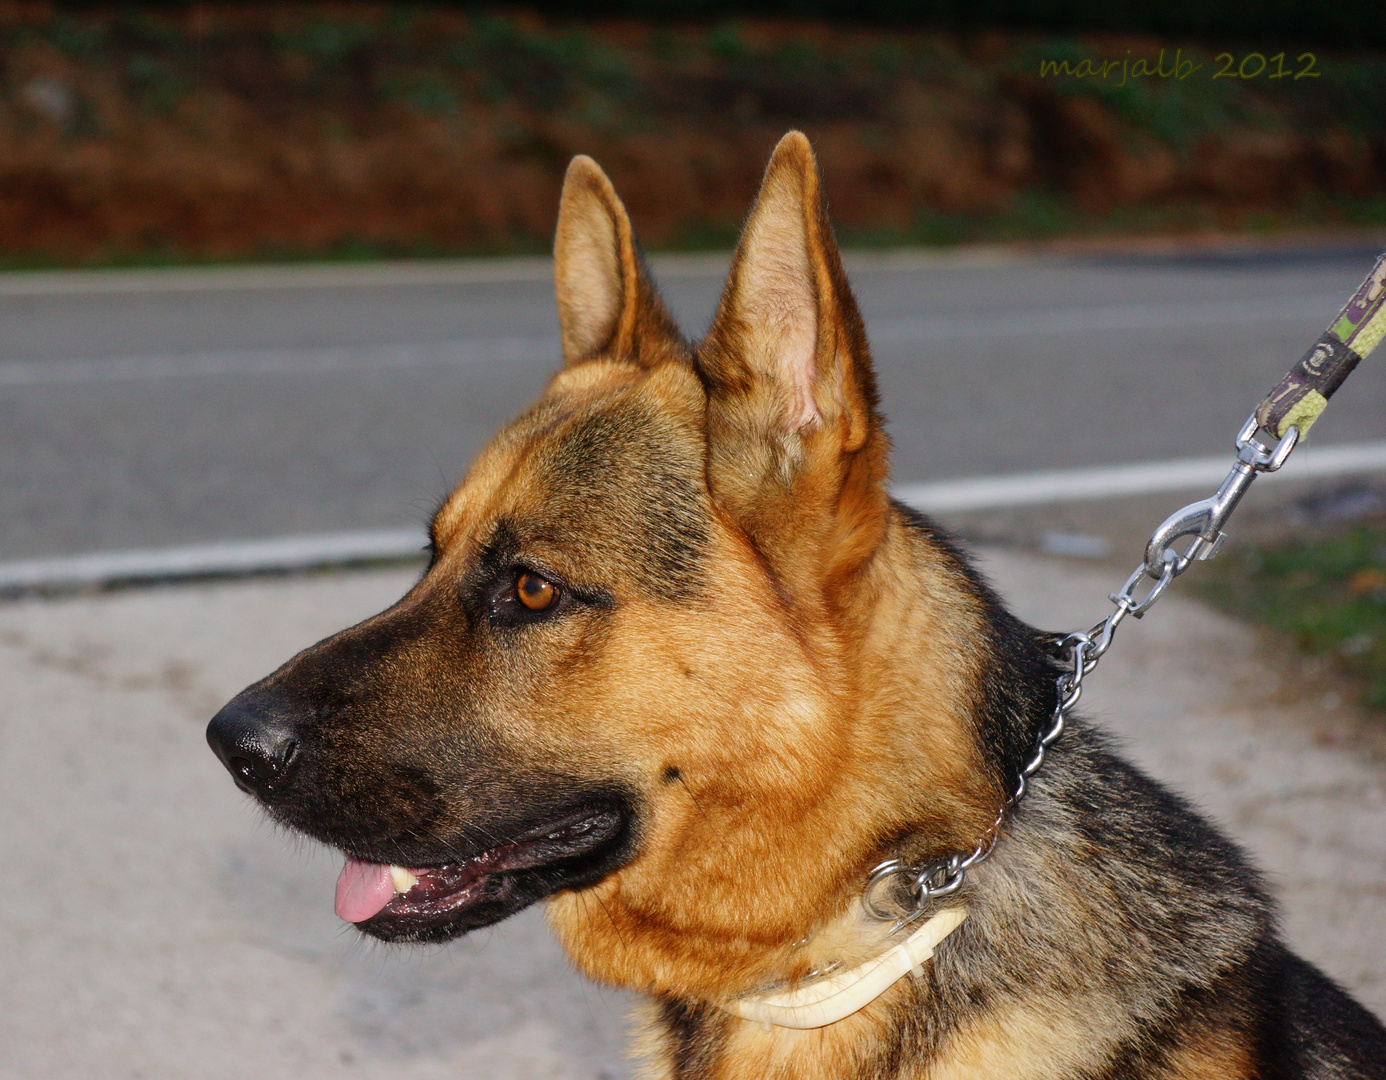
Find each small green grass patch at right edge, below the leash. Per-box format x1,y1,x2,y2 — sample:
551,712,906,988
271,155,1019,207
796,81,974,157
1199,520,1386,711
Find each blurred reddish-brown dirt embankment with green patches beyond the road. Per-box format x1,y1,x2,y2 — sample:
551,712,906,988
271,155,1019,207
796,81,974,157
0,4,1386,265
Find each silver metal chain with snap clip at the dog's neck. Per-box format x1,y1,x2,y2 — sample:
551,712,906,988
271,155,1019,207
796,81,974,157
862,416,1299,932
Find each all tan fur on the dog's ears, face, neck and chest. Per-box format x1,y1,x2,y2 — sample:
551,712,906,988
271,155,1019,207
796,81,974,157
385,134,1252,1080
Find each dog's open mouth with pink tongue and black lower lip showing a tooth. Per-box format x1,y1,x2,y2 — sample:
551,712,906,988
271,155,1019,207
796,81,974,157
335,807,625,941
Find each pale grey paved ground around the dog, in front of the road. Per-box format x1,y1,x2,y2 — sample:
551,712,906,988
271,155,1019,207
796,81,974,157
0,550,1386,1080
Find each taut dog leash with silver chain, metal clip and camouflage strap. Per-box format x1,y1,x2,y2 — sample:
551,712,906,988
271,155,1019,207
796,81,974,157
862,246,1386,930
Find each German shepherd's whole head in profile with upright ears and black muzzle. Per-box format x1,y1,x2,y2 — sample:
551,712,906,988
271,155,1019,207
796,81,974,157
208,133,998,993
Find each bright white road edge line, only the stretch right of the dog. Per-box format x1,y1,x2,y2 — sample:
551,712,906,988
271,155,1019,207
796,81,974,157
894,442,1386,513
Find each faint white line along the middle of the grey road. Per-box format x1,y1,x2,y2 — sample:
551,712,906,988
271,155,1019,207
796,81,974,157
0,295,1342,387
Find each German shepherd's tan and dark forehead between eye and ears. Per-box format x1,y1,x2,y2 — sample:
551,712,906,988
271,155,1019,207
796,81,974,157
432,363,710,596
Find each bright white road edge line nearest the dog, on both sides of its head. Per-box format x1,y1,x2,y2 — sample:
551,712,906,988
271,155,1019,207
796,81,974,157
0,442,1386,596
